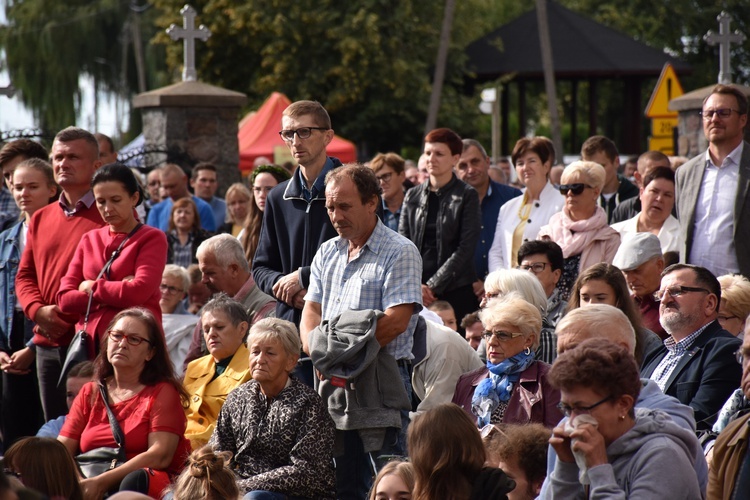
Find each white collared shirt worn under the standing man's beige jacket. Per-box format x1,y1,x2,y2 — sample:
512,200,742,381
687,142,743,276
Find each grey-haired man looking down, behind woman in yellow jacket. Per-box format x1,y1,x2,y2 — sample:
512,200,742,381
183,233,276,369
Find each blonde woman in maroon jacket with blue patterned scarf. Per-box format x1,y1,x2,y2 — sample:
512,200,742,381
453,293,562,428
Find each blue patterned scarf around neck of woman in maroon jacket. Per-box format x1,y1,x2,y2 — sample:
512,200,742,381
471,351,535,428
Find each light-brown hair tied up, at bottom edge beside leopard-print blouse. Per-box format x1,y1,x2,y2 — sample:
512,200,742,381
164,446,240,500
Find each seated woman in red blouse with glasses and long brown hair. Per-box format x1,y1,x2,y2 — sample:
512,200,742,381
58,308,190,500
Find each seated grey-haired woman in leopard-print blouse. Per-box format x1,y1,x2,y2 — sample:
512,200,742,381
209,318,335,500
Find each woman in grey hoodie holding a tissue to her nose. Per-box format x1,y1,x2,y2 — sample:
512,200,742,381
541,339,705,499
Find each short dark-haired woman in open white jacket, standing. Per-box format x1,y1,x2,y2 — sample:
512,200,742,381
487,137,565,272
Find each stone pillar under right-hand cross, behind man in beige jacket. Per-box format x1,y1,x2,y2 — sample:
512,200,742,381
669,84,750,158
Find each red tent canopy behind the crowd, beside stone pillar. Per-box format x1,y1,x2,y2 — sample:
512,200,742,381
237,92,357,174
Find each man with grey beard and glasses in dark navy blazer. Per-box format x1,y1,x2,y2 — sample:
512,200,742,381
641,264,742,430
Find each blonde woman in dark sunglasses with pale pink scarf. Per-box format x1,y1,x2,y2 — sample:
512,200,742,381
539,161,620,300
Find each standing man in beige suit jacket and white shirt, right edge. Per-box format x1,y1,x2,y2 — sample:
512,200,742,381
675,85,750,276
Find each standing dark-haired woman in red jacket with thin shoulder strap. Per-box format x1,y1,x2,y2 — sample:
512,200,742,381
57,163,167,359
